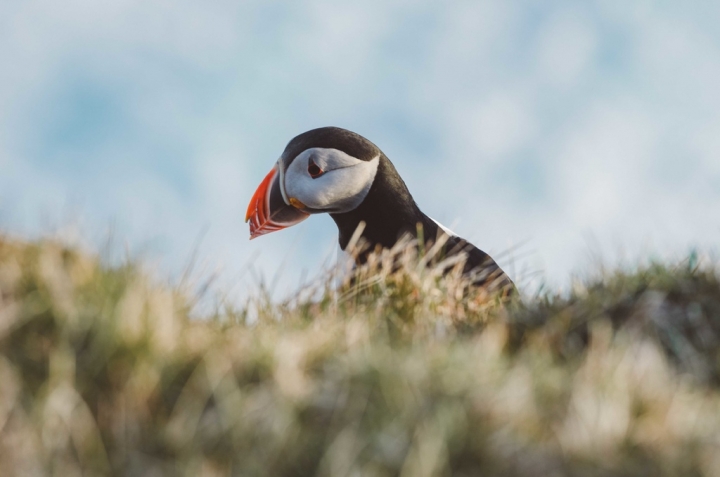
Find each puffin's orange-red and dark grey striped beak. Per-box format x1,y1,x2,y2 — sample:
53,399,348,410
245,165,309,240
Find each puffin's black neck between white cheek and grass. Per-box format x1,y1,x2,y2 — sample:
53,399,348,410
330,156,437,250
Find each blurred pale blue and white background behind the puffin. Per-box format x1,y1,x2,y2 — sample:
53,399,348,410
0,0,720,296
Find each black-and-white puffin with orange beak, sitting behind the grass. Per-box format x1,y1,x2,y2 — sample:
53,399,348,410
245,127,515,296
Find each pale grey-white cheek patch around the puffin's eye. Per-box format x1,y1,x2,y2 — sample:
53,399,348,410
285,148,380,213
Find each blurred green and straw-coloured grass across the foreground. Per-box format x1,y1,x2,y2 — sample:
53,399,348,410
0,237,720,477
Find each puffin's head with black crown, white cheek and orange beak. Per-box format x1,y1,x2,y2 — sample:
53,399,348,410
245,127,382,239
